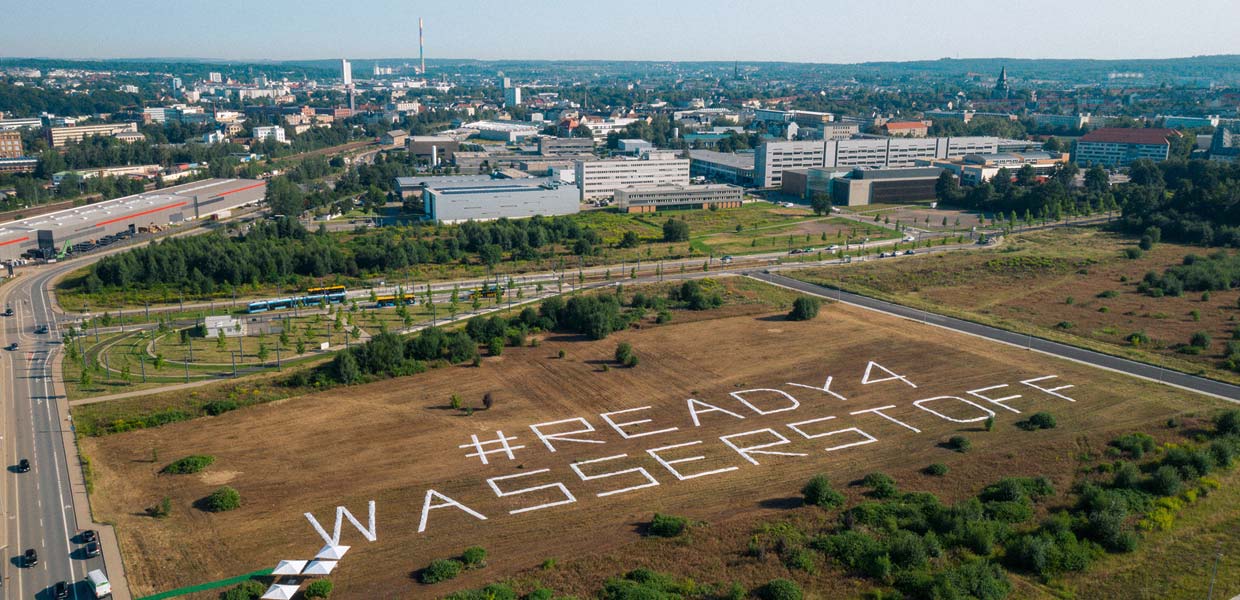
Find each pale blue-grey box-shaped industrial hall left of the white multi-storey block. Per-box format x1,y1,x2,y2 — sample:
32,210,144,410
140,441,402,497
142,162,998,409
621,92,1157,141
421,177,580,223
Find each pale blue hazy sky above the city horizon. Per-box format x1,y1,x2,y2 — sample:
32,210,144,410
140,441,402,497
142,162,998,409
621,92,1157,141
9,0,1240,62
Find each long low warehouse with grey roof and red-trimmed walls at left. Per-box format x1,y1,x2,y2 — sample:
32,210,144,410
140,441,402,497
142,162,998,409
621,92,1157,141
0,179,267,260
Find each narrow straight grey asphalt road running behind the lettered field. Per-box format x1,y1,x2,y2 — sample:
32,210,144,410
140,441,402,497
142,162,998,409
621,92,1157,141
746,269,1240,404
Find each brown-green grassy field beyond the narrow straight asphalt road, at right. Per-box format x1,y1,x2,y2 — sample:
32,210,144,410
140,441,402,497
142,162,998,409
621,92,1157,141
792,228,1240,383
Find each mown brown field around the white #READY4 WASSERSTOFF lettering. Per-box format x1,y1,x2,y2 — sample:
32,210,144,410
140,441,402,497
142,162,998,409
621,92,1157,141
82,288,1236,599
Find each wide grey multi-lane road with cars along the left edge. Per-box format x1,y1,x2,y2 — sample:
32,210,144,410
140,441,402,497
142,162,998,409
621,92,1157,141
0,269,104,599
